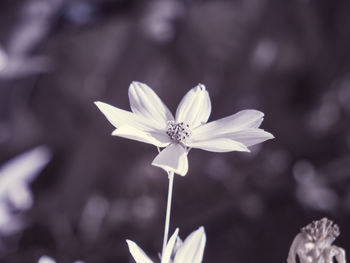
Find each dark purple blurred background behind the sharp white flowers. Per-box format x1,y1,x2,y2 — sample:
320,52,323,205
0,0,350,263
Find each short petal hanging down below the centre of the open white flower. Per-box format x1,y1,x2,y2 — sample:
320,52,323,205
152,143,188,176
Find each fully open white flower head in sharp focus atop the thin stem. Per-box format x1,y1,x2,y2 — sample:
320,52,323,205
95,82,274,175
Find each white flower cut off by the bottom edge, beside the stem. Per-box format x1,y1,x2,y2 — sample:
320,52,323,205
126,227,206,263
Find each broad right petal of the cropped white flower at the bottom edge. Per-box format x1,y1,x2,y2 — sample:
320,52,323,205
174,227,206,263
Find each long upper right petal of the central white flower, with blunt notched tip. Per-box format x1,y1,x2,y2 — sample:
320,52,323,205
192,110,264,140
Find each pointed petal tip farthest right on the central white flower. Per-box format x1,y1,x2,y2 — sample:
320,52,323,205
225,129,275,147
